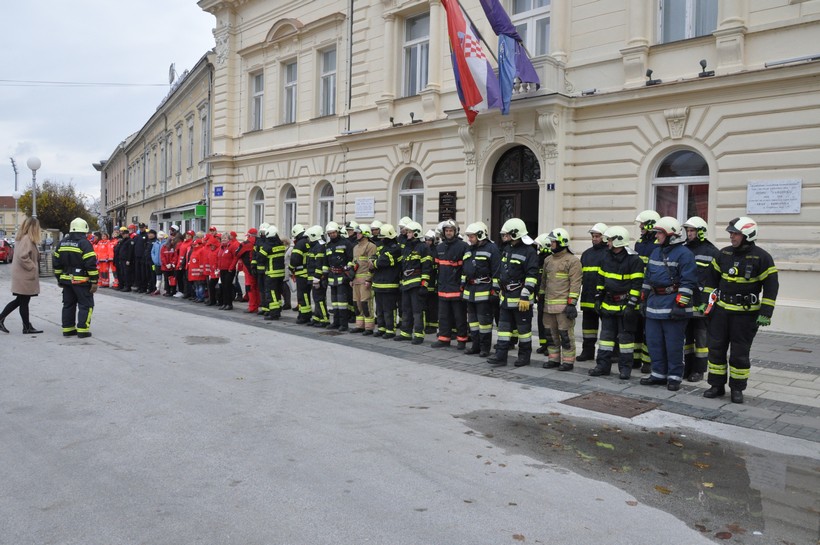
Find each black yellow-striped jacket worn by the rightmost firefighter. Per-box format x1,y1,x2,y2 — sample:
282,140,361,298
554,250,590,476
703,242,780,318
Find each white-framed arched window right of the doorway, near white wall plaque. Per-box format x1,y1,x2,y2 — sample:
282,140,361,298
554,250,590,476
652,150,709,221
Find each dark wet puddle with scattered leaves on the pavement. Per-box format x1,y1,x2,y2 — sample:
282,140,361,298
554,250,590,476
459,411,820,545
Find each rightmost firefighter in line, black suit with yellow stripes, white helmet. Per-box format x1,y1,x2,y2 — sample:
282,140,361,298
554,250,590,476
701,217,780,403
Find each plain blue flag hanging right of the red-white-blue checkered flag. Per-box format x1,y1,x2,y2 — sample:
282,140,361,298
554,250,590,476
480,0,541,115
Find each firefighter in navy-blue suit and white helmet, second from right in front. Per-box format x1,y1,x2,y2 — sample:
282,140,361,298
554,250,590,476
641,216,698,392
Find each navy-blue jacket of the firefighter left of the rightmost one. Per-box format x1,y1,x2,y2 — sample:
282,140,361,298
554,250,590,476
642,243,698,320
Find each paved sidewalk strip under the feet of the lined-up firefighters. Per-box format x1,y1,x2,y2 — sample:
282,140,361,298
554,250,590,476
97,289,820,443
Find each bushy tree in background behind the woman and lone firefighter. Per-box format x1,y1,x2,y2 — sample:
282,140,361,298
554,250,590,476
17,180,98,233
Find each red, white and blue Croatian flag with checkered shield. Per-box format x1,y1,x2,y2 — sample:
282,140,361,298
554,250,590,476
441,0,501,125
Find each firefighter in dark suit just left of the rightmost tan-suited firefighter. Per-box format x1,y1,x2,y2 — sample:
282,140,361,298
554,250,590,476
487,218,538,367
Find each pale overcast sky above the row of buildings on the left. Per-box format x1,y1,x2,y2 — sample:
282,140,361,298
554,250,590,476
0,0,216,202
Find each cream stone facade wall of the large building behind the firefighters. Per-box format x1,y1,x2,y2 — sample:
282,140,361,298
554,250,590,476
191,0,820,331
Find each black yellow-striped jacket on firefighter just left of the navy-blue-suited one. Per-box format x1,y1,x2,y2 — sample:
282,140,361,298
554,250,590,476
595,248,644,315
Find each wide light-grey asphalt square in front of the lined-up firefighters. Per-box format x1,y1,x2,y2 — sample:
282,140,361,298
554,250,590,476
0,266,820,545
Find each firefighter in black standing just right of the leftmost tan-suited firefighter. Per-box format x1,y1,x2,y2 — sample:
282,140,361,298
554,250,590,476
371,223,401,339
